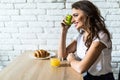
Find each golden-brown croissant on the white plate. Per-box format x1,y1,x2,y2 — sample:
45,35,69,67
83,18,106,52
34,49,50,58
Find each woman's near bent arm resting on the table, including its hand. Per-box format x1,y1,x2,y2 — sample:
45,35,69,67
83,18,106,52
67,41,106,73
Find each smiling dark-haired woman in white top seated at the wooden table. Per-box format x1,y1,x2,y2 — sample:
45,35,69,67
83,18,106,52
58,0,114,80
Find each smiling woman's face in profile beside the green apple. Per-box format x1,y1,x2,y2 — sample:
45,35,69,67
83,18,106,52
72,8,85,30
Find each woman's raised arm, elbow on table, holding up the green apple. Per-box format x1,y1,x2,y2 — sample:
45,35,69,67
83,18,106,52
58,20,76,59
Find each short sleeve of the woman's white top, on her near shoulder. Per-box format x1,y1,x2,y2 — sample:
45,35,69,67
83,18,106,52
94,32,112,48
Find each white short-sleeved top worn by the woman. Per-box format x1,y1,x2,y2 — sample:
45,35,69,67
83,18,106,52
76,32,112,76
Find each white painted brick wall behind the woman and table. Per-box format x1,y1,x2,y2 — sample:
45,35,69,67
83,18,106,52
0,0,120,80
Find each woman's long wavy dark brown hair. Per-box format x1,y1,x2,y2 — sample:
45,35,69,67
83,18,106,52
72,0,110,48
